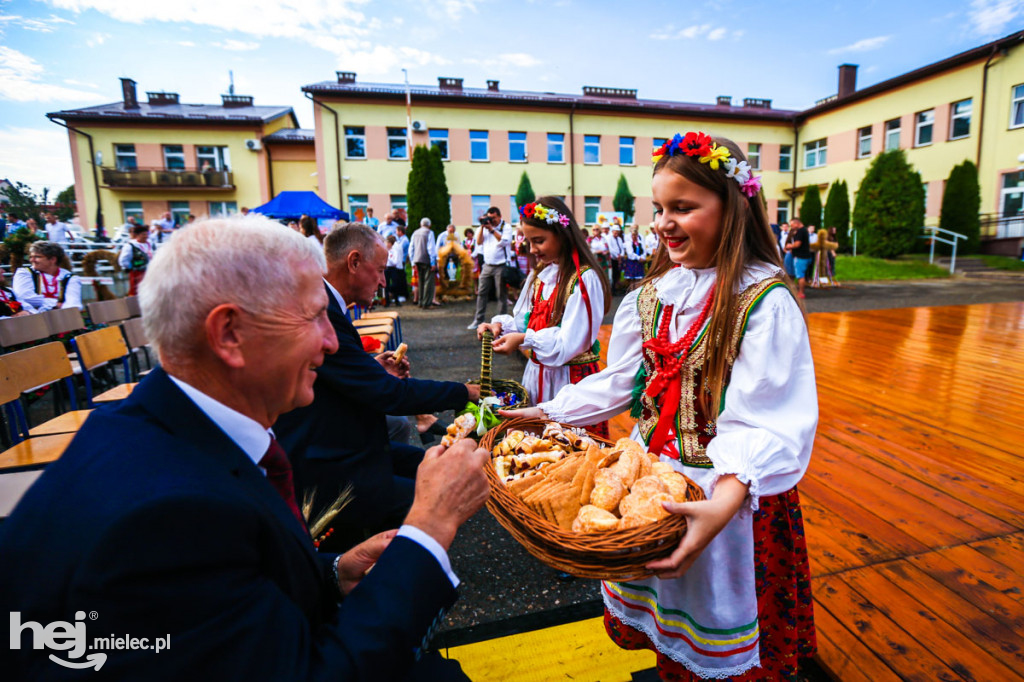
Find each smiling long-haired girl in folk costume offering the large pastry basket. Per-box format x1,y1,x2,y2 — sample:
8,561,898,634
504,133,817,680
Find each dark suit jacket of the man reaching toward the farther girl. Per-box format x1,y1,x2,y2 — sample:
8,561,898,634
273,285,469,526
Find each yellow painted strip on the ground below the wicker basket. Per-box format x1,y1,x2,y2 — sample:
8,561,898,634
442,617,654,682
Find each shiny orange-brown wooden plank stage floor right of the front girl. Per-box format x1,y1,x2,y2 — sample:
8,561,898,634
602,302,1024,682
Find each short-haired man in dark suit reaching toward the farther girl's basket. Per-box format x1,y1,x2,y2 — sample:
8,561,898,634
274,223,480,551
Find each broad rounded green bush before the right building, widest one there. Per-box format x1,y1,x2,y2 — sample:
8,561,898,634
853,150,925,258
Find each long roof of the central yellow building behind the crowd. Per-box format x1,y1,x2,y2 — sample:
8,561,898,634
302,79,798,122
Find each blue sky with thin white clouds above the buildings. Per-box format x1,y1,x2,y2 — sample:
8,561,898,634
0,0,1024,191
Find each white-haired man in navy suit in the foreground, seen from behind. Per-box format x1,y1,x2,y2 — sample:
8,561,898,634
0,217,487,682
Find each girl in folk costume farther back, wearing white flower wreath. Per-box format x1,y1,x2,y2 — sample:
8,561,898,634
477,197,611,435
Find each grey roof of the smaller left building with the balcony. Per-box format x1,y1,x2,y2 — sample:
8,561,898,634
46,101,298,125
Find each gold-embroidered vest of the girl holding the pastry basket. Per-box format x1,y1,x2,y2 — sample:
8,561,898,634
634,276,785,469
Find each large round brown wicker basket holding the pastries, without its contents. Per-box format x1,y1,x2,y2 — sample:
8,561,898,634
480,417,705,581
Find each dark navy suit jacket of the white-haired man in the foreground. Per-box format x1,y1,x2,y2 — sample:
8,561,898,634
0,369,455,682
